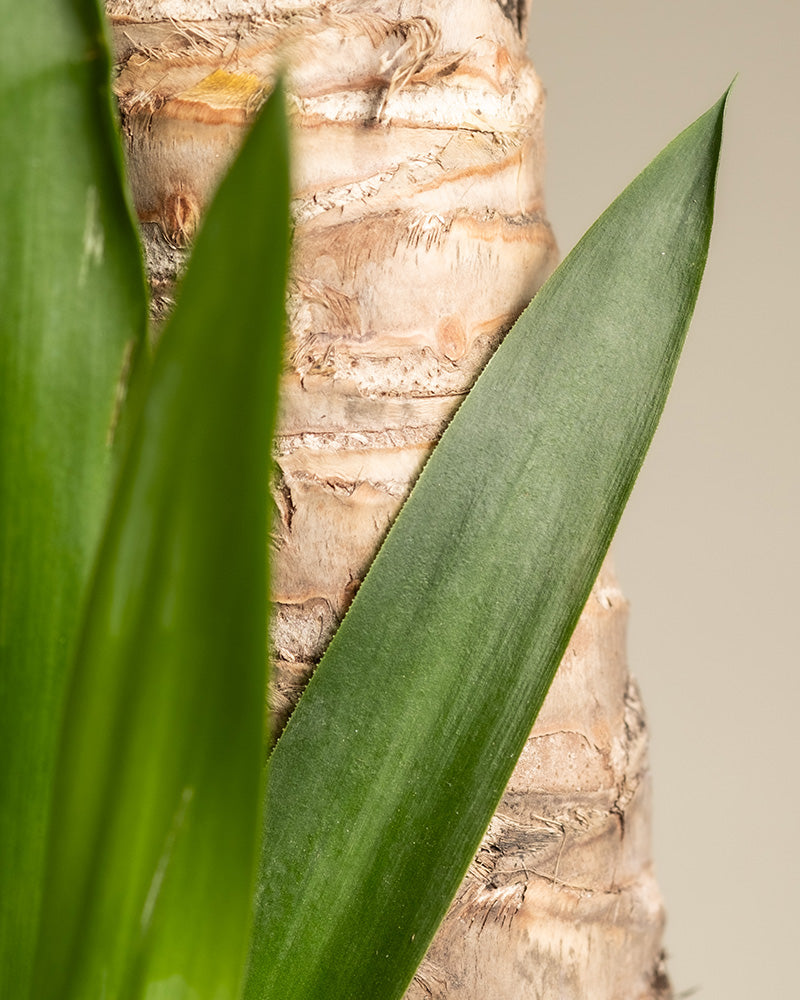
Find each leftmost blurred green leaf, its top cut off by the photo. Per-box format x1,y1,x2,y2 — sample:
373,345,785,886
0,0,147,998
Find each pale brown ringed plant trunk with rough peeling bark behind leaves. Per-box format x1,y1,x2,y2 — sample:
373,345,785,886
108,0,669,1000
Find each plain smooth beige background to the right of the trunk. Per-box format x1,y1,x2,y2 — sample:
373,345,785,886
530,0,800,1000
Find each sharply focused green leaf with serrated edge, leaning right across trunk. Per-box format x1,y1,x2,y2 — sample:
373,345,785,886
245,90,725,1000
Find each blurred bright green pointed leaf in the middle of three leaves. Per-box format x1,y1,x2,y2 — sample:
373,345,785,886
36,84,289,1000
